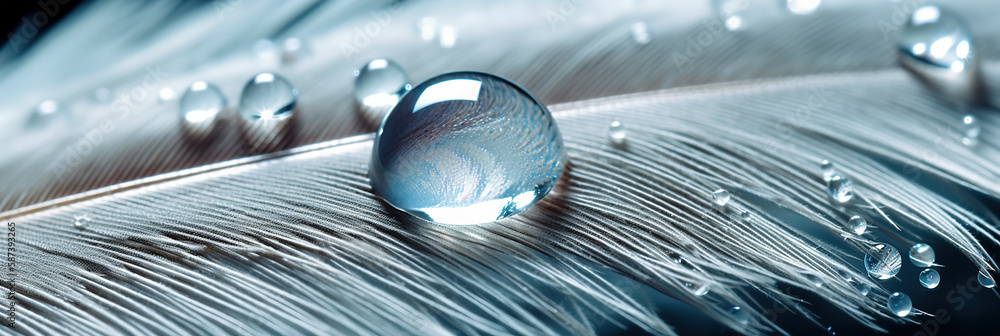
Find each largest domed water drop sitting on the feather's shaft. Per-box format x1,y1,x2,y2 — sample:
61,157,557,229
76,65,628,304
368,72,567,224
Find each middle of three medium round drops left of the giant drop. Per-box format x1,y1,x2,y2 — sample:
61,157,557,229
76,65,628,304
239,72,299,151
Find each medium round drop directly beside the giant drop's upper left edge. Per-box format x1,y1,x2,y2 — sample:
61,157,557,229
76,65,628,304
354,58,410,123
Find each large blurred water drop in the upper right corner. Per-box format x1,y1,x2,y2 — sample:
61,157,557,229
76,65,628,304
897,6,979,102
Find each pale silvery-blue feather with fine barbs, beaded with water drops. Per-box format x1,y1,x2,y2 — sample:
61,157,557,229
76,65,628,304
0,1,1000,335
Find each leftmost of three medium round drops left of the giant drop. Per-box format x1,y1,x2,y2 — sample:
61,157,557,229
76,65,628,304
177,81,226,139
